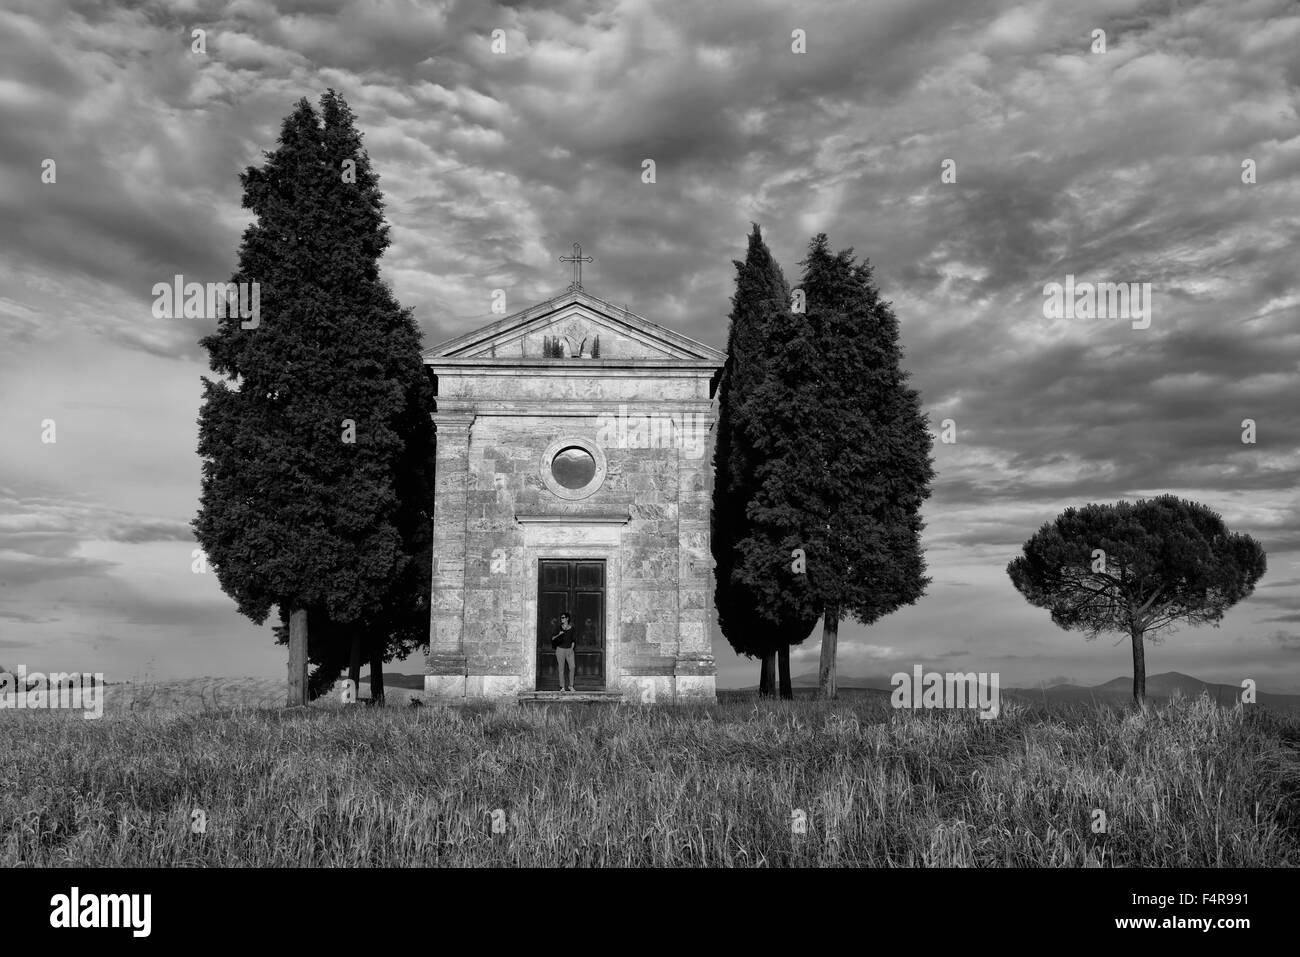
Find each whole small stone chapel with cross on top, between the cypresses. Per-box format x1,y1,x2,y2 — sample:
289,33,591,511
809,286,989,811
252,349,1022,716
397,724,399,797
424,257,725,703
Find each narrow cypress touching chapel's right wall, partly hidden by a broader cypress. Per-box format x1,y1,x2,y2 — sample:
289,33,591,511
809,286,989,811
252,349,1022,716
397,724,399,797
710,224,816,698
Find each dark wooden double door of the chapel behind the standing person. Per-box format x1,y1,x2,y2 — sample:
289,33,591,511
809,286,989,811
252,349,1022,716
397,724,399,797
537,558,605,692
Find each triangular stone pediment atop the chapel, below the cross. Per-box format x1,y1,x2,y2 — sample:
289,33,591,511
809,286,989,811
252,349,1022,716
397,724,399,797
424,289,727,365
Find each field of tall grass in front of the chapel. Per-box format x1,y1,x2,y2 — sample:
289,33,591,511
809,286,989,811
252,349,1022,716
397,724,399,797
0,684,1300,867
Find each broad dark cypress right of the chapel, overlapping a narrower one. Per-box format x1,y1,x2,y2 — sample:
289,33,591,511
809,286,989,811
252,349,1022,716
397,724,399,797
736,234,933,697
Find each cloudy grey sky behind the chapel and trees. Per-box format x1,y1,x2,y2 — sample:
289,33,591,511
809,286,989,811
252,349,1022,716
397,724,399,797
0,0,1300,693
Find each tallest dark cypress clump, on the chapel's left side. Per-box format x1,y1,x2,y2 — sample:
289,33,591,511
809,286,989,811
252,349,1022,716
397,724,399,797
194,90,432,705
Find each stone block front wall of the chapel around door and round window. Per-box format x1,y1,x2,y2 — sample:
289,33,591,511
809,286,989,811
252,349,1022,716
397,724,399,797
425,304,718,703
